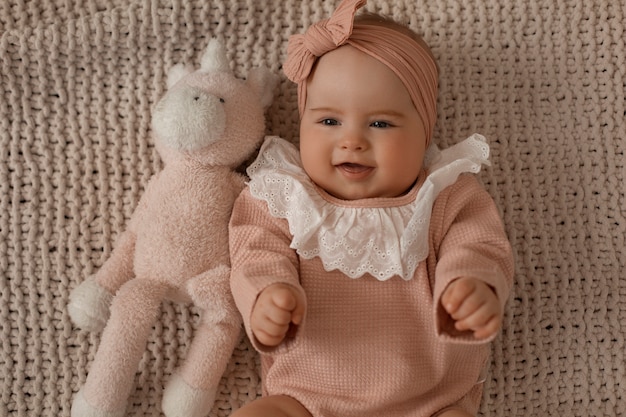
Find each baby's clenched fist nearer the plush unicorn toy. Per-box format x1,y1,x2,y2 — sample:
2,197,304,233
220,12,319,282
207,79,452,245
250,284,304,347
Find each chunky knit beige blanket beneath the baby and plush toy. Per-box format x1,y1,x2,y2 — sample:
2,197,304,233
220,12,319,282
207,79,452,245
0,0,626,417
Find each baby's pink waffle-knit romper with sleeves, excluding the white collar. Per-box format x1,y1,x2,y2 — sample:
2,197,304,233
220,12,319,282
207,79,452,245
230,170,513,417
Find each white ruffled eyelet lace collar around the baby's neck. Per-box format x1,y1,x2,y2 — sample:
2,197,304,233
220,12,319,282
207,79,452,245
248,134,489,281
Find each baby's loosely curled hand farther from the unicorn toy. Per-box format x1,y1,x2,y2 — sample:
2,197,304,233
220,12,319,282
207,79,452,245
441,277,502,339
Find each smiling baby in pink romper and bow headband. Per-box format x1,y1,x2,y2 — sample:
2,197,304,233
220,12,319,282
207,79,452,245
230,0,513,417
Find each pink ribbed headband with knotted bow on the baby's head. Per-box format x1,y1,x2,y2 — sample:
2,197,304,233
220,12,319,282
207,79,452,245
283,0,438,145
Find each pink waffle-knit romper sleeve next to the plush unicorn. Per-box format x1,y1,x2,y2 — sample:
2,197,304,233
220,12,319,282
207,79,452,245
229,188,306,353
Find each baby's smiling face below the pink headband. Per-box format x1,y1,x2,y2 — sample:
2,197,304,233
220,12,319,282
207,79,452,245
300,45,426,200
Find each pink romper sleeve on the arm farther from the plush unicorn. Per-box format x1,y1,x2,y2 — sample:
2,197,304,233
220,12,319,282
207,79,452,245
430,175,514,343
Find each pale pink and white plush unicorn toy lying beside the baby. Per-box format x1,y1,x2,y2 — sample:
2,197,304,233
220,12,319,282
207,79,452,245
68,39,276,417
